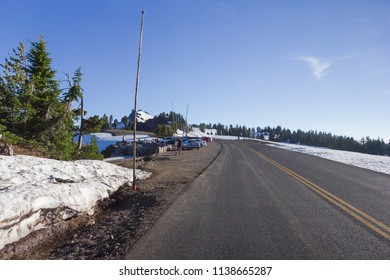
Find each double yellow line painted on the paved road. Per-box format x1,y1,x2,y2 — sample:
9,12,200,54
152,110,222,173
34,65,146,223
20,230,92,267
249,147,390,240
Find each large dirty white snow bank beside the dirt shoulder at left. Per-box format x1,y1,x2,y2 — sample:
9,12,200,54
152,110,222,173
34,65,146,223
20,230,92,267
0,156,150,249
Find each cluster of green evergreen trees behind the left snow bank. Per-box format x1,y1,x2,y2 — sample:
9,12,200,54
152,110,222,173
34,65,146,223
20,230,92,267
0,36,101,160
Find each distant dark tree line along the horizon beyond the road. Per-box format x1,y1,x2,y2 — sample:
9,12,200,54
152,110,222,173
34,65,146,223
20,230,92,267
96,111,390,158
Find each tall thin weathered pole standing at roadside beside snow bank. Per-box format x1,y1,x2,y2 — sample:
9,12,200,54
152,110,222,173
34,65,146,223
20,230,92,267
133,11,145,191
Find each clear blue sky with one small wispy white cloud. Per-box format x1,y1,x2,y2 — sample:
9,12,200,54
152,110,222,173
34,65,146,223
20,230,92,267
0,0,390,142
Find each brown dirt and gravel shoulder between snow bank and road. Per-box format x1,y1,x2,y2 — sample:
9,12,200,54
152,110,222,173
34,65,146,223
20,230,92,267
0,142,222,260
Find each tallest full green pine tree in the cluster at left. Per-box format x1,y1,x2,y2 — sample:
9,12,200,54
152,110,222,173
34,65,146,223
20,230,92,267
26,37,74,160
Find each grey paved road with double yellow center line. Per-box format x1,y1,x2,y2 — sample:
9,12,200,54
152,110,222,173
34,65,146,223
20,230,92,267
126,141,390,259
